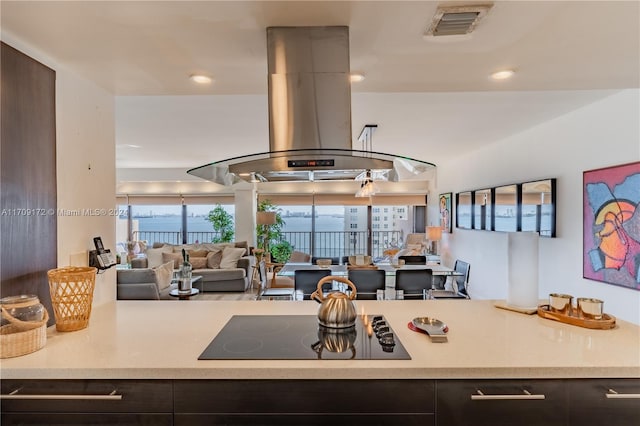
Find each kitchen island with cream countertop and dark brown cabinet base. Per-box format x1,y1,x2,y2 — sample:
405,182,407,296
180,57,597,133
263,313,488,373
0,300,640,425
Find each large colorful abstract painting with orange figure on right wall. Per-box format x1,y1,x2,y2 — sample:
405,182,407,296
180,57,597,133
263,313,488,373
583,162,640,290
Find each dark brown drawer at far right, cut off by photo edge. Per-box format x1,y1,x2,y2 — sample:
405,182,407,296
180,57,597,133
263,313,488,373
569,379,640,426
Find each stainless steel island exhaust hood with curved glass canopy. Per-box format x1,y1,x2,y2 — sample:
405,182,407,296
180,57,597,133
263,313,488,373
187,26,435,185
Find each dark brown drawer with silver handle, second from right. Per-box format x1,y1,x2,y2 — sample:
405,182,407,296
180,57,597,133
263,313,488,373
436,380,567,426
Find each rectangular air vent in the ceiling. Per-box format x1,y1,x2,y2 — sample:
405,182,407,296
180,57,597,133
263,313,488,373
426,4,493,37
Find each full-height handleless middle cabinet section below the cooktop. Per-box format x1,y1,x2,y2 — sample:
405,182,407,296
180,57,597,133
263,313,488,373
174,380,435,426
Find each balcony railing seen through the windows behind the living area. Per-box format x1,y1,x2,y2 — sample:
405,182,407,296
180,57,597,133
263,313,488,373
133,231,401,258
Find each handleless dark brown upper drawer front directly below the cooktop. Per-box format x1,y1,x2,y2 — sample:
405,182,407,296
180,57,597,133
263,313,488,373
174,380,435,414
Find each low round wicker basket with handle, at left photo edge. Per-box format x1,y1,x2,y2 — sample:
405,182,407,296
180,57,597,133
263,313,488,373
0,308,49,358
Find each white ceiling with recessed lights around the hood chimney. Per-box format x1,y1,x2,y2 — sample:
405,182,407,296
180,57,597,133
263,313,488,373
1,0,640,177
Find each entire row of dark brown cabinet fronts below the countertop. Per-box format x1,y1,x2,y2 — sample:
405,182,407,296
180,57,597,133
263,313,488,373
0,379,640,426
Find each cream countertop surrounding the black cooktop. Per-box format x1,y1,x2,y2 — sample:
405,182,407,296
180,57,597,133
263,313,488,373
0,300,640,379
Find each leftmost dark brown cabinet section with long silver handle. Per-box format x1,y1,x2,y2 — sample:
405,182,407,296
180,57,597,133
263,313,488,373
0,380,173,426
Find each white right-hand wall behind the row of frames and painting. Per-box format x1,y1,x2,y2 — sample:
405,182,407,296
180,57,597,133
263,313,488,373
438,89,640,324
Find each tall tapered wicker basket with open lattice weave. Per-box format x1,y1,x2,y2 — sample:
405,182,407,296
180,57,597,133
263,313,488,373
47,266,97,331
